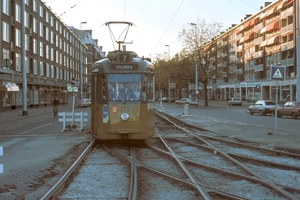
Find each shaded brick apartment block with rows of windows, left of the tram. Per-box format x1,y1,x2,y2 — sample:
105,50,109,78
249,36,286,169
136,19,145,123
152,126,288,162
0,0,102,110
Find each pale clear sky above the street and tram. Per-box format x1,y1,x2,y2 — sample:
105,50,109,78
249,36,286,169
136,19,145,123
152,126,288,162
44,0,275,59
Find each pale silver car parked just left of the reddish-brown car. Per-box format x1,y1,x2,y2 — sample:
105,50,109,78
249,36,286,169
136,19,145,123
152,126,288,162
248,100,276,116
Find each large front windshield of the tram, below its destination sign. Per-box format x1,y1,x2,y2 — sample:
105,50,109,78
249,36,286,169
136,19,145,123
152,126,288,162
107,74,142,101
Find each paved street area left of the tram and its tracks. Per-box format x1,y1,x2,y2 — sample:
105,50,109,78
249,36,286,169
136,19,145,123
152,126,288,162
0,105,91,199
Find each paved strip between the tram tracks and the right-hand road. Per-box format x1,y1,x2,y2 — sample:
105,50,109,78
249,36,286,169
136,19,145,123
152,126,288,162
156,101,300,154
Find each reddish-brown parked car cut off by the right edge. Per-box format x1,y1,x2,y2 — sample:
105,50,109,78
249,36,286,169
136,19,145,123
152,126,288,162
277,101,300,119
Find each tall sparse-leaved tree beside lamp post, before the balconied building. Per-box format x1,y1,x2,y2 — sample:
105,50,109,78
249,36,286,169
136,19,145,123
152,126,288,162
179,19,223,106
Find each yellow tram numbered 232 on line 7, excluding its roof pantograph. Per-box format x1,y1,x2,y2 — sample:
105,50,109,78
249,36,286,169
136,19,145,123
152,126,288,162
91,51,155,144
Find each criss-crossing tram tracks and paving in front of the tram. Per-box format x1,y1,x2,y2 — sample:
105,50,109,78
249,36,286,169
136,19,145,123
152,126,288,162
42,111,300,199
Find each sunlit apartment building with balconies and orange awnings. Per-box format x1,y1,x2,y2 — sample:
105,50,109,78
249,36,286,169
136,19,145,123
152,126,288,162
209,0,300,101
